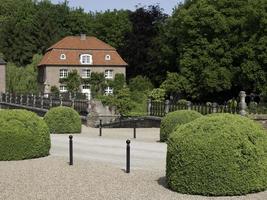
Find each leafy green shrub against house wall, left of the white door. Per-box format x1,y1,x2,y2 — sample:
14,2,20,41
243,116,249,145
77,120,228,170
60,70,82,93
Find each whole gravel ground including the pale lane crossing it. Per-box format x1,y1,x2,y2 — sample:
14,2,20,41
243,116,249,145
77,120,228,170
0,127,267,200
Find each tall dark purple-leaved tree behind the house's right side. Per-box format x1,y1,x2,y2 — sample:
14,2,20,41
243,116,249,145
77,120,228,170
122,5,167,83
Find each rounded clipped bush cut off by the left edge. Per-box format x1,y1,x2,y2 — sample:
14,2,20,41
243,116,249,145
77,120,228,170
0,110,51,160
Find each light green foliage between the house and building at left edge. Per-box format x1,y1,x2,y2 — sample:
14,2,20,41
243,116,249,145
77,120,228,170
6,55,42,94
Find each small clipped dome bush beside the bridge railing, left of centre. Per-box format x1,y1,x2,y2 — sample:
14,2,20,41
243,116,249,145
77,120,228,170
44,106,82,133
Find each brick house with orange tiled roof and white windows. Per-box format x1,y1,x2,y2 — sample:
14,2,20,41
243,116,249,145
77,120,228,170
38,34,127,99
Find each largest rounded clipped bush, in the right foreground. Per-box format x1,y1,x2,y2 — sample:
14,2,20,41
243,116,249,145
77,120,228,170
166,114,267,196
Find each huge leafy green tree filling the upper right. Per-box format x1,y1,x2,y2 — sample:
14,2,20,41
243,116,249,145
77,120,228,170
164,0,267,100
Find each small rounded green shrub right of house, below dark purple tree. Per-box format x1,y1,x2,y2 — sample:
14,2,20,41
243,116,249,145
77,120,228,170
129,75,154,93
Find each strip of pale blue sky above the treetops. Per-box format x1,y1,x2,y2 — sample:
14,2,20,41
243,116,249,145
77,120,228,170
51,0,182,15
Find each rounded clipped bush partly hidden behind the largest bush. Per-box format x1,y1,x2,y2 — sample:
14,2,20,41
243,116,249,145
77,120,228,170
160,110,202,142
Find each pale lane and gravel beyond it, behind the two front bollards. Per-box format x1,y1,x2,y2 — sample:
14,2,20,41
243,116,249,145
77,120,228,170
50,127,167,170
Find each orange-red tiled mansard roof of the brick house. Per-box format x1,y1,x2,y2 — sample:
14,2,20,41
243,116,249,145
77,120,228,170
38,36,127,66
